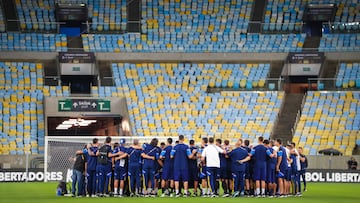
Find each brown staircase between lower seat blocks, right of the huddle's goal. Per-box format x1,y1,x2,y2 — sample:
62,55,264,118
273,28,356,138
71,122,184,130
273,94,304,144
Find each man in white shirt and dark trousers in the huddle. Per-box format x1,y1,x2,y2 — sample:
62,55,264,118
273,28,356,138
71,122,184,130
201,137,226,197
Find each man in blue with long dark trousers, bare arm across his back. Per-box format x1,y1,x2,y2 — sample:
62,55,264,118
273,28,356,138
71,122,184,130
228,139,250,197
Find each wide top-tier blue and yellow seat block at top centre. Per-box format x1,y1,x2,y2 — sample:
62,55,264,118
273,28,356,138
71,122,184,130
141,0,253,36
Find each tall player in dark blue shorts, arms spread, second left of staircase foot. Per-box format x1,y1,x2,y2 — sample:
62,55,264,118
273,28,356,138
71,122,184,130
250,137,273,197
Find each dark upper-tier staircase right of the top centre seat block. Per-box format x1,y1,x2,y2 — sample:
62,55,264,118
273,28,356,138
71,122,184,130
248,0,267,33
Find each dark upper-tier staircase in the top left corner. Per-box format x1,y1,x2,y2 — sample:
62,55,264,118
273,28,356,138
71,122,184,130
2,0,19,32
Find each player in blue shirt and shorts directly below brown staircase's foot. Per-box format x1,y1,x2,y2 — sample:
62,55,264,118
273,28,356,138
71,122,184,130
275,139,288,196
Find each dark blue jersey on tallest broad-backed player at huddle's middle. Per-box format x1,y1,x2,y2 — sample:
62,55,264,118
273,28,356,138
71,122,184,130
171,144,191,170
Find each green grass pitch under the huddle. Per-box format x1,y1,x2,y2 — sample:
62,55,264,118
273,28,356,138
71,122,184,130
0,183,360,203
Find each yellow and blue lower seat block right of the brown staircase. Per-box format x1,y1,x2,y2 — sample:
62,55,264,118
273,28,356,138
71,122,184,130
293,91,360,155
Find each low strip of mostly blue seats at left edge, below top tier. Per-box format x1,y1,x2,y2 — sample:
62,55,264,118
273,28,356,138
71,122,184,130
0,33,67,52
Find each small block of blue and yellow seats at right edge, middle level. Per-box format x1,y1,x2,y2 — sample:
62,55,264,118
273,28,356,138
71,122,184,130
335,63,360,88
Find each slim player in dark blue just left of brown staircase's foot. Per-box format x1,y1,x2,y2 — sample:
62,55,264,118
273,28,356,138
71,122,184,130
264,140,277,197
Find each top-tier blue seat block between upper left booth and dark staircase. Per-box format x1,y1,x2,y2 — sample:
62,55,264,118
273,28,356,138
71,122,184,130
60,0,127,32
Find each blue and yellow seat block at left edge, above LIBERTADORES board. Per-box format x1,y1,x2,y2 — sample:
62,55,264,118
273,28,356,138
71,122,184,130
0,62,45,154
